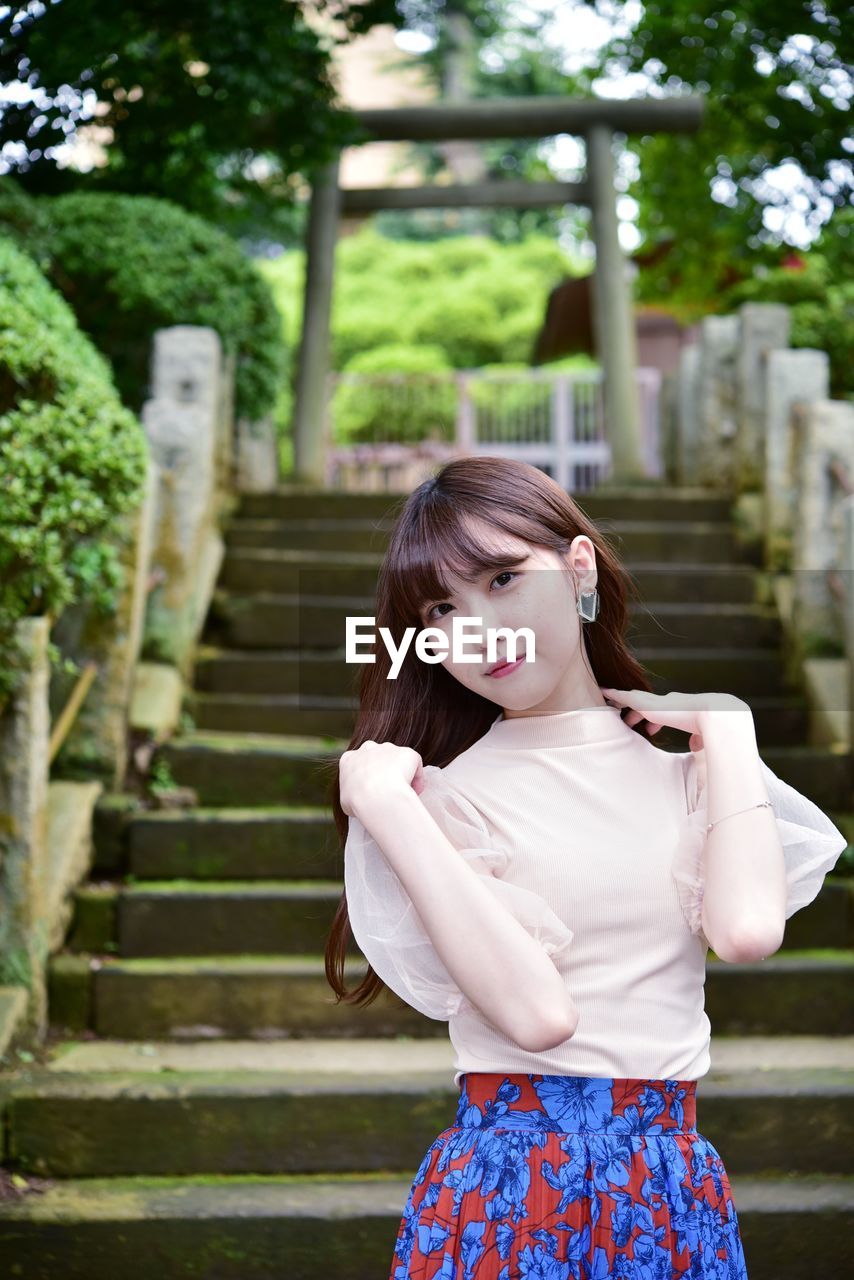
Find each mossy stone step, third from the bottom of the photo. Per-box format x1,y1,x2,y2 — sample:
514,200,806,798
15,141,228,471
49,950,854,1039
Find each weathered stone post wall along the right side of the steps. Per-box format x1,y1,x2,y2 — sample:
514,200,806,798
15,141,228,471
665,296,854,741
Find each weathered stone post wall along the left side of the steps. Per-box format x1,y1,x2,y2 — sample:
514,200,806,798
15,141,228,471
0,325,272,1055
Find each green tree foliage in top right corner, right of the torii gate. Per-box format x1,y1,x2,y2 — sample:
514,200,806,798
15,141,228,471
602,0,854,296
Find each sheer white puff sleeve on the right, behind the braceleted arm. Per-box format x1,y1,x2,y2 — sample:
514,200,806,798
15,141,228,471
672,748,848,946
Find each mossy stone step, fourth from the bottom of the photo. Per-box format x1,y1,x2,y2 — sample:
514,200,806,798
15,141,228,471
67,875,854,957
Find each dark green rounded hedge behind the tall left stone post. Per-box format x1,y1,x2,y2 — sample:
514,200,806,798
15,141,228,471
0,178,286,420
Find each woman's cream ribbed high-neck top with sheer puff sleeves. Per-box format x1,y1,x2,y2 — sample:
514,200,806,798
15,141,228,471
344,705,846,1084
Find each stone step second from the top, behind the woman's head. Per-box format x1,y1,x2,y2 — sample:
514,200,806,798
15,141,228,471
225,516,739,563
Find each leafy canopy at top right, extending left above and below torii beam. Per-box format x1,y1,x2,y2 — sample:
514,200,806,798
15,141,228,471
389,0,854,300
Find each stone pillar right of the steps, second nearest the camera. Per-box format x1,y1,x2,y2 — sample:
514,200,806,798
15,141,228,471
763,347,830,570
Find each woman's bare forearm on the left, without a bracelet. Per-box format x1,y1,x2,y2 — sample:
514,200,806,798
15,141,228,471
357,791,577,1052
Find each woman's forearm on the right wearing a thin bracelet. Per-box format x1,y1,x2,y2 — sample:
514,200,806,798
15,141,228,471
703,708,786,961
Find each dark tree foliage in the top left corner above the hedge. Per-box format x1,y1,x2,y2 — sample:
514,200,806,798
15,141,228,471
0,0,398,234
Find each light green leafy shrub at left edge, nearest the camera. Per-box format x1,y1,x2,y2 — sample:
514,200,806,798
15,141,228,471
0,238,149,700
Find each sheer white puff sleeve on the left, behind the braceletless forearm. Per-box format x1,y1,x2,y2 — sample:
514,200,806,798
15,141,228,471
344,764,574,1021
